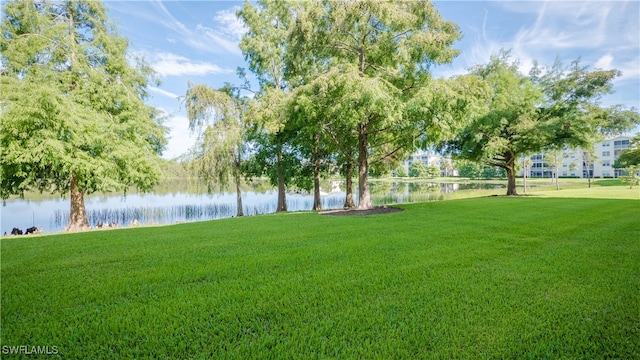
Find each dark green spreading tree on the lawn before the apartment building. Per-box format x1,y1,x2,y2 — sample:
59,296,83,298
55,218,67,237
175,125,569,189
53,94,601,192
447,52,640,195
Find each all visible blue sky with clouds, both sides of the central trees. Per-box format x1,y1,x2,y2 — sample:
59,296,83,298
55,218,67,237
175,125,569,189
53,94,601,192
105,0,640,158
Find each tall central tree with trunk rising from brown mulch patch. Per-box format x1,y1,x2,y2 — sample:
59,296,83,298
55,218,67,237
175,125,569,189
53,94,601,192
290,0,460,209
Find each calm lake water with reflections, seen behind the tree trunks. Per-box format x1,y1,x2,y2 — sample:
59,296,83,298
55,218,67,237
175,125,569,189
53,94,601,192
1,182,504,233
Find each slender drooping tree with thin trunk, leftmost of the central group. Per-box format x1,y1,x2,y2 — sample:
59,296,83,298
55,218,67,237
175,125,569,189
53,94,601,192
185,84,248,217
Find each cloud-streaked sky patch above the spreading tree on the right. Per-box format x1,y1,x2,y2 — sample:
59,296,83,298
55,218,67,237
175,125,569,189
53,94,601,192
434,0,640,108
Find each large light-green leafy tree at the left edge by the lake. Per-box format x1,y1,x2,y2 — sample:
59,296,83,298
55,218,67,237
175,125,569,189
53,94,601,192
0,0,166,230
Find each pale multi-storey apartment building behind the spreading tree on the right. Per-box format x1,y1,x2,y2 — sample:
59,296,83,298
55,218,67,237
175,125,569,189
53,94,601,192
520,136,631,178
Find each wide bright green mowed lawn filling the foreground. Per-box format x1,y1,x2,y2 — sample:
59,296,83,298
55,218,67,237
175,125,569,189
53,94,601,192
1,197,640,359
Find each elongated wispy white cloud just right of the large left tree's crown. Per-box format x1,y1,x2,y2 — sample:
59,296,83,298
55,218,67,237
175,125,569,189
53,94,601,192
150,53,233,77
